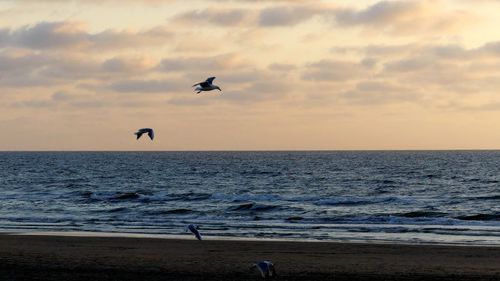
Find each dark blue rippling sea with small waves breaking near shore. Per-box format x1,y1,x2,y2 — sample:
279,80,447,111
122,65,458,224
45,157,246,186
0,151,500,245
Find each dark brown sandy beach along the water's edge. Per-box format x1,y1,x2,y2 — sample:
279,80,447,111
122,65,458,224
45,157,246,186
0,235,500,281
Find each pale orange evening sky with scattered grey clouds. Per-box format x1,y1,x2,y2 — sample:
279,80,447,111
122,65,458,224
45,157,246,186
0,0,500,151
